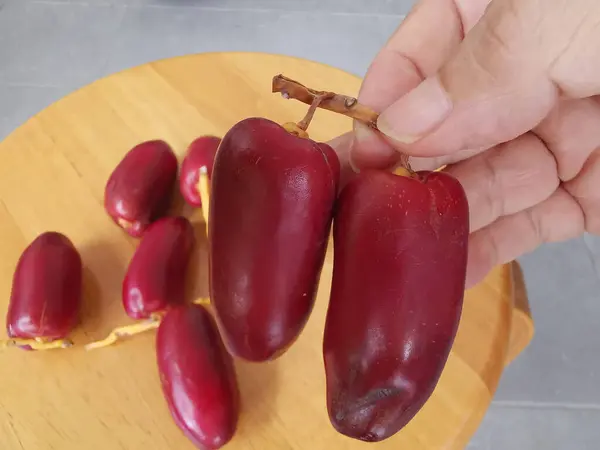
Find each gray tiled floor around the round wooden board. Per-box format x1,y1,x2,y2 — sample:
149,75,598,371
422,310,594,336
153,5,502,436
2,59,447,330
0,0,600,450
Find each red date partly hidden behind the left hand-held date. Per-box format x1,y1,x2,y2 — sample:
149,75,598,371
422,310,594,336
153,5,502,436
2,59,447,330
179,136,221,208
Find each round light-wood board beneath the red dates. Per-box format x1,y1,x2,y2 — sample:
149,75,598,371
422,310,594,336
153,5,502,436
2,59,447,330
0,53,533,450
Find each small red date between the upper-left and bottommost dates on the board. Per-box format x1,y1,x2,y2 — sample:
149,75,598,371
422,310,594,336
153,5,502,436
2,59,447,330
123,217,196,319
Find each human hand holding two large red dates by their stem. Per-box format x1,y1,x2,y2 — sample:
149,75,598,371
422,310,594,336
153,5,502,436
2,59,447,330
332,0,600,287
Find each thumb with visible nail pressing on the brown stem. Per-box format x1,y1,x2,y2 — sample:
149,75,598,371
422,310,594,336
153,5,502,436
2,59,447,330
377,0,600,157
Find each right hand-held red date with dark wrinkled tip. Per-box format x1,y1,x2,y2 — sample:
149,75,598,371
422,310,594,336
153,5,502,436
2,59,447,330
323,171,469,442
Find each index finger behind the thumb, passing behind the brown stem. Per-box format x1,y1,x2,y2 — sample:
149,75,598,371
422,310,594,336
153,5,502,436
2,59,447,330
351,0,490,168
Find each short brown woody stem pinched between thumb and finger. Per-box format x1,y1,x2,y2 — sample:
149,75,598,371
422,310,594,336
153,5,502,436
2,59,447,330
273,75,379,129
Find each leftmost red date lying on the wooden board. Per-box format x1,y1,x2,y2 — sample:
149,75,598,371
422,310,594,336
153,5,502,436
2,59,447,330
6,231,83,340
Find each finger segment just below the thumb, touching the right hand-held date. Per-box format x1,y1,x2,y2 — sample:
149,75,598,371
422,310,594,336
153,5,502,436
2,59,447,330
444,133,559,232
